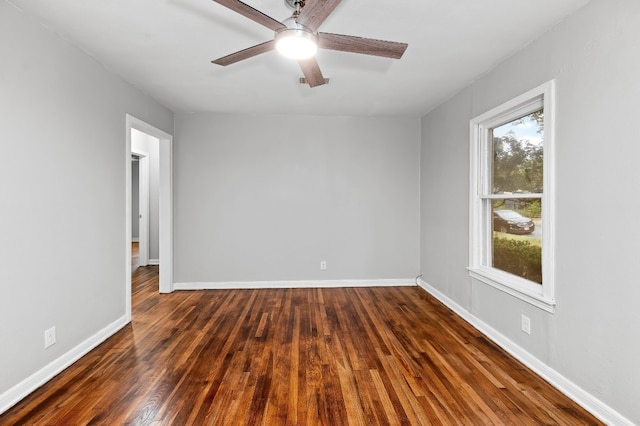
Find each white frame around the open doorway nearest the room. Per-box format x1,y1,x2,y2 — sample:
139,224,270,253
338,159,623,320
125,114,173,320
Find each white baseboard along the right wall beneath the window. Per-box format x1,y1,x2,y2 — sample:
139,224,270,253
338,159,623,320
418,279,634,426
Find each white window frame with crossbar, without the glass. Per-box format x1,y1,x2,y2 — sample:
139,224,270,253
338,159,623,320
469,80,556,312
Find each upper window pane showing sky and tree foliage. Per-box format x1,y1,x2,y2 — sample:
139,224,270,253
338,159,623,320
491,109,544,194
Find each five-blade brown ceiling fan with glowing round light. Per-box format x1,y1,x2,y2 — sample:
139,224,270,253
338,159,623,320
211,0,408,87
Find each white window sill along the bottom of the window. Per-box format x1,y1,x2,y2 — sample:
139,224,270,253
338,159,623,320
469,267,556,313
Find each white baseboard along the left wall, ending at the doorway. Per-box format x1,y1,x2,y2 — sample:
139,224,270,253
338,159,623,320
0,316,129,414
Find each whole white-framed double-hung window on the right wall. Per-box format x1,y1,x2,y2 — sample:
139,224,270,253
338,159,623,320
469,81,555,312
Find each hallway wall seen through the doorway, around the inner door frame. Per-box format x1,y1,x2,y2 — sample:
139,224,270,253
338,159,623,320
131,129,160,263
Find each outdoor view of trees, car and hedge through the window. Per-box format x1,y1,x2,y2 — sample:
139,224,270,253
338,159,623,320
487,109,544,284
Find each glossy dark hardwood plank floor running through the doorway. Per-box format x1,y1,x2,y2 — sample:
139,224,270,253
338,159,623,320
0,267,600,425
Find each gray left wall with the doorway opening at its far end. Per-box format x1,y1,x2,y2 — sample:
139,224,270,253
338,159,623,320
0,1,173,394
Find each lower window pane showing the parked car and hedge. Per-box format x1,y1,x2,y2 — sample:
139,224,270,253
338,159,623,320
486,198,542,284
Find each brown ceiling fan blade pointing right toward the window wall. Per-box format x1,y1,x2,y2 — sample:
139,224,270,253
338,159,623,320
318,33,409,59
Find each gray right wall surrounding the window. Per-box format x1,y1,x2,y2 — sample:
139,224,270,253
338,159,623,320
421,0,640,423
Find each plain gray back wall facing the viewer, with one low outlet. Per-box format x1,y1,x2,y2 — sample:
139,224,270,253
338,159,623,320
174,114,420,283
